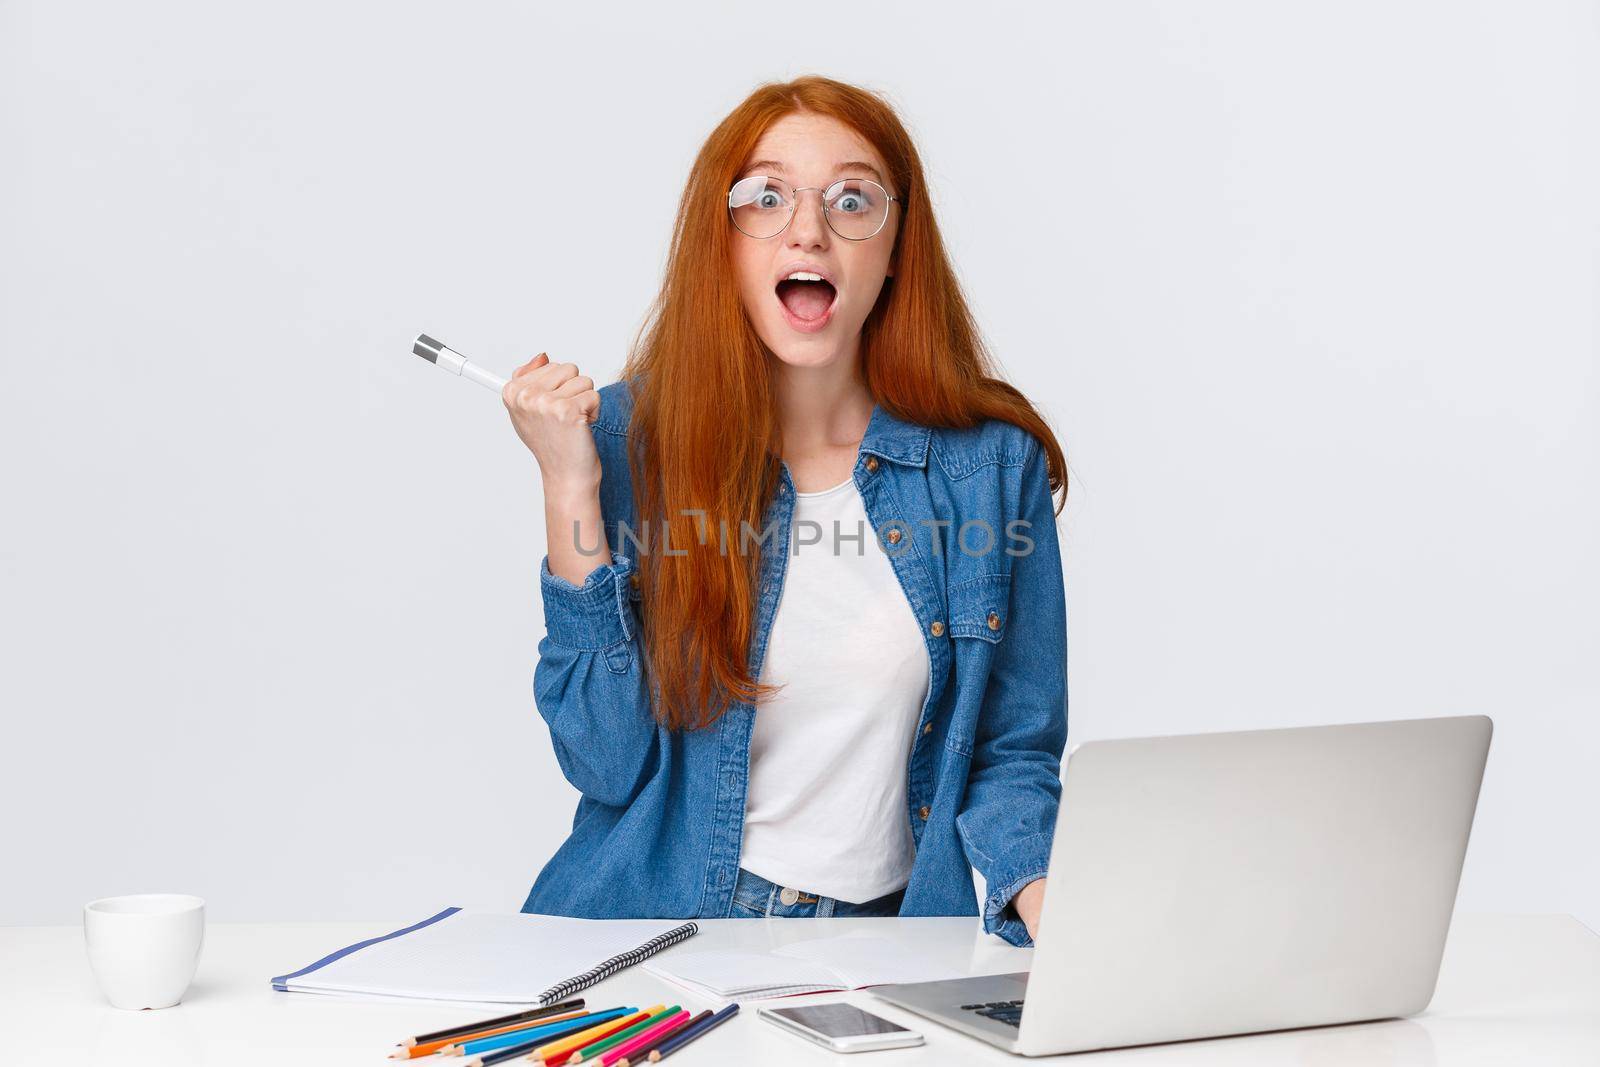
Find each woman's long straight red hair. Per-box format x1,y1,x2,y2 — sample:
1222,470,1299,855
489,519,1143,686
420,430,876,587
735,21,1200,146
622,77,1067,729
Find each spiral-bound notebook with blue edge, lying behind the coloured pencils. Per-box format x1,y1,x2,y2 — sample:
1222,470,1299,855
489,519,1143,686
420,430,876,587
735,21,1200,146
272,907,699,1005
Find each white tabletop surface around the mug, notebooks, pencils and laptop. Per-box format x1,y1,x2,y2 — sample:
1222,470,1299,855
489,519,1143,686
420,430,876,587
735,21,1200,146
0,915,1600,1067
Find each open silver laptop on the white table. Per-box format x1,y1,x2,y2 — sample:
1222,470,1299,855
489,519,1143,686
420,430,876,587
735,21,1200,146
872,715,1493,1056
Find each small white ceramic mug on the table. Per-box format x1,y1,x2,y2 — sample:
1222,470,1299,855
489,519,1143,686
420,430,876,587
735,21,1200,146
83,893,205,1009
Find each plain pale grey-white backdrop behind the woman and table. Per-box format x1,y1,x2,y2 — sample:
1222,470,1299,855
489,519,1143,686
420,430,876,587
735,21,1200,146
0,0,1600,925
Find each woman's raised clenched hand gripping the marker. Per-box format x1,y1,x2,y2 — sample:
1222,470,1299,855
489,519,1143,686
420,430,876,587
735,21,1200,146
501,352,600,499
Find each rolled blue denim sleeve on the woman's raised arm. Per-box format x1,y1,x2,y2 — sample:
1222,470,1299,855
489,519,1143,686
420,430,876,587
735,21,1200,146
533,552,661,806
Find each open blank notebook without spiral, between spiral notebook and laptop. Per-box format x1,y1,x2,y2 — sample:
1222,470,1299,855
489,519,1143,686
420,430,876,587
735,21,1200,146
645,934,968,1000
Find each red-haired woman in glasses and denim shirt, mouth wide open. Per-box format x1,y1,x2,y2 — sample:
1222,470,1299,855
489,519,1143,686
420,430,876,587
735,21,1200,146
504,77,1067,945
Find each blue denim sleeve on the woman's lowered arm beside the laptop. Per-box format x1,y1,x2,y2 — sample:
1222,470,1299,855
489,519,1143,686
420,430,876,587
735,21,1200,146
957,440,1067,945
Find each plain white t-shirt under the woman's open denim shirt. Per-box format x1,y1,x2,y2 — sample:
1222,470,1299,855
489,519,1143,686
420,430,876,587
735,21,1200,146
739,478,930,904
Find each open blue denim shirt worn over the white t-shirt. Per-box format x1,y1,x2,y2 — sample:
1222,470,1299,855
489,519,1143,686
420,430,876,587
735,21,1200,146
522,381,1067,945
